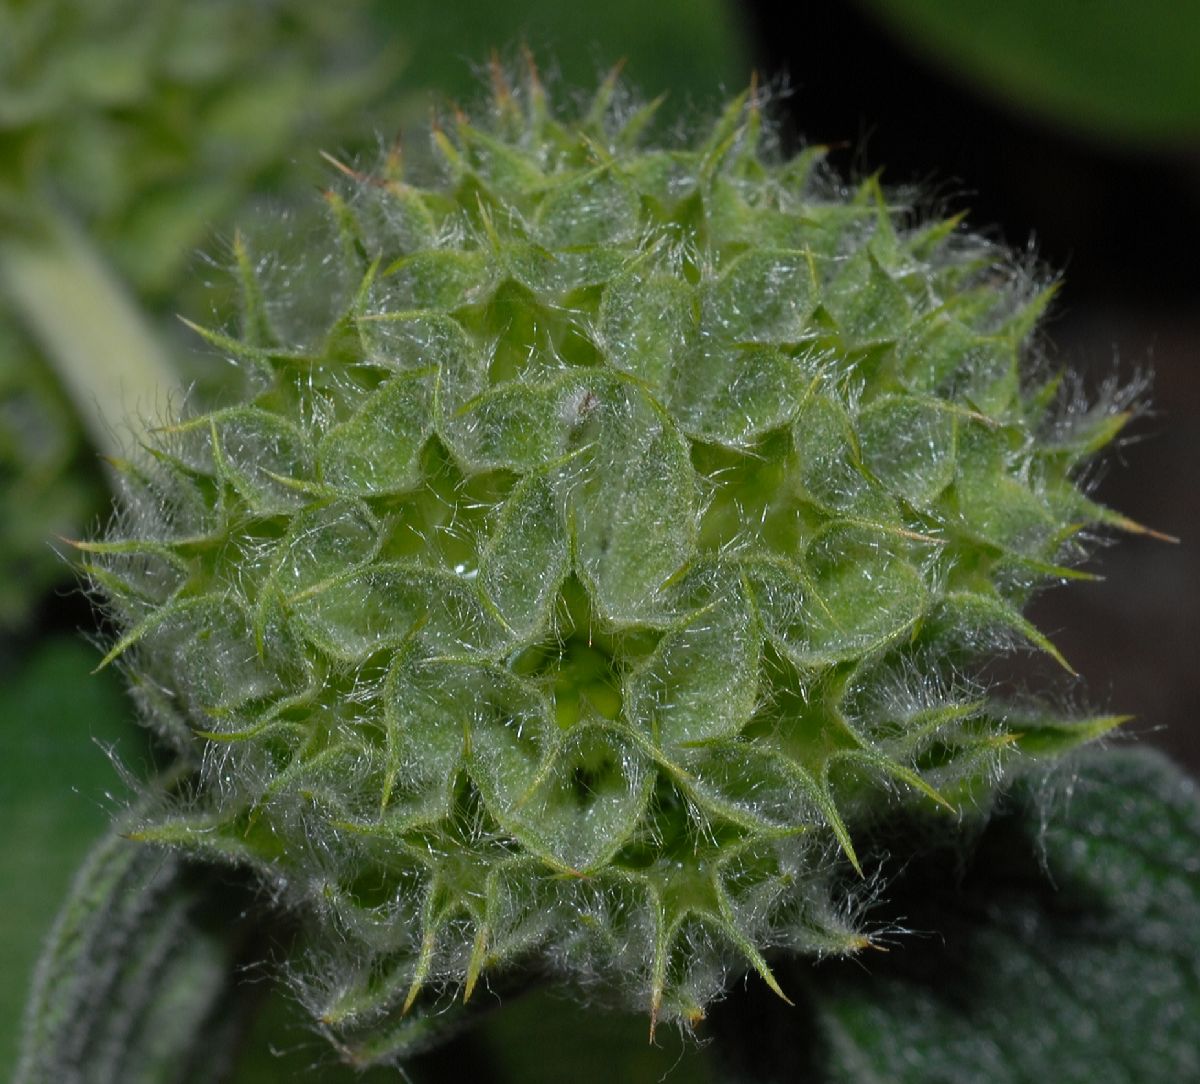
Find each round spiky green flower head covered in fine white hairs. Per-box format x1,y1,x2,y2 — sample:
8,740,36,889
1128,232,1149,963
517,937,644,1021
84,70,1124,1060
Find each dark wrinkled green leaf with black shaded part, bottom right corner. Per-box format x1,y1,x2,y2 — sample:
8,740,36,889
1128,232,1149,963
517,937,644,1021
719,750,1200,1084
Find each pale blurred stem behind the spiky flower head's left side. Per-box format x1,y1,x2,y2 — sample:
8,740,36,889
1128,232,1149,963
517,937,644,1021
0,216,180,456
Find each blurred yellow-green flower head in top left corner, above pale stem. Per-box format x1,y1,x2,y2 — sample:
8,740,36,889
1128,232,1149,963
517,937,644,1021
0,0,400,292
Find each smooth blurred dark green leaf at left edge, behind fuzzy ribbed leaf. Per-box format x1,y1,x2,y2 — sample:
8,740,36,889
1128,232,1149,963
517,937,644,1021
0,637,146,1068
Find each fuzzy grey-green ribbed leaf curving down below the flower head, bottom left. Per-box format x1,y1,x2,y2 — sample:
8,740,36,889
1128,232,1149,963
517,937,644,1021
16,824,238,1084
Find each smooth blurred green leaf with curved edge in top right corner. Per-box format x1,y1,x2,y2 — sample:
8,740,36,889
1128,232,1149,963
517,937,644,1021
860,0,1200,145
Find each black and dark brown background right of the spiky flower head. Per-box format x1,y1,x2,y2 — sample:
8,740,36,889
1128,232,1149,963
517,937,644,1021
742,0,1200,774
